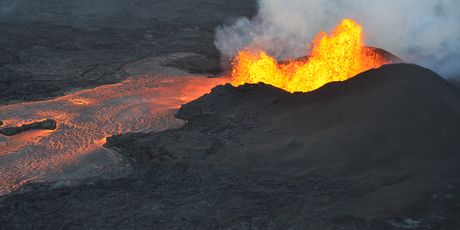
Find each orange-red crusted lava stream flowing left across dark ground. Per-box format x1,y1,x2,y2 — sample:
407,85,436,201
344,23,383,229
0,76,228,194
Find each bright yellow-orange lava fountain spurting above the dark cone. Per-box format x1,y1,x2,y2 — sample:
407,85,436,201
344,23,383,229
232,19,389,92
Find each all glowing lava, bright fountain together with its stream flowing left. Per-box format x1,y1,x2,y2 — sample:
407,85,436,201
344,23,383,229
0,19,389,194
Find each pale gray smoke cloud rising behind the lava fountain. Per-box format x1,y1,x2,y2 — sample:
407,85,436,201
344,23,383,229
215,0,460,77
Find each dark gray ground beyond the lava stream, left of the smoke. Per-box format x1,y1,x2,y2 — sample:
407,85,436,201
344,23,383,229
0,0,256,104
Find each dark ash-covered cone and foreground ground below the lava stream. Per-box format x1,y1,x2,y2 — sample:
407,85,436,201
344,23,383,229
0,64,460,230
